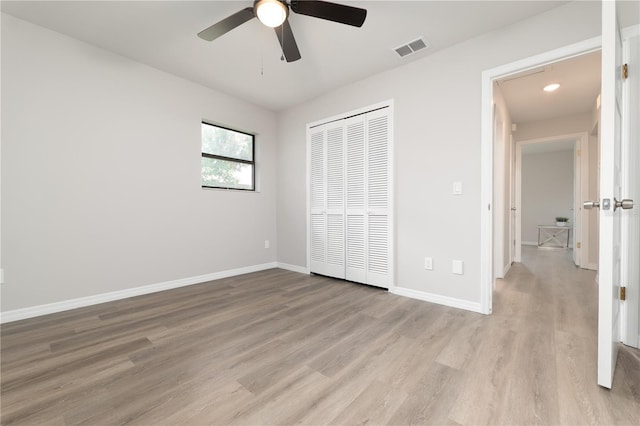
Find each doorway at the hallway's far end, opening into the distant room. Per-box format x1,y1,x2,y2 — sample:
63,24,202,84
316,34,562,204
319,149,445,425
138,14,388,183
514,132,597,270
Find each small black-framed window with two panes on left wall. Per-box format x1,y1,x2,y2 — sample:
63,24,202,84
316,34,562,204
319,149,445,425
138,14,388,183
202,122,255,191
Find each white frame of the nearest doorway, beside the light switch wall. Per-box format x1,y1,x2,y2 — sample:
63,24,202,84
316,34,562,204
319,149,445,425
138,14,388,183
480,36,602,314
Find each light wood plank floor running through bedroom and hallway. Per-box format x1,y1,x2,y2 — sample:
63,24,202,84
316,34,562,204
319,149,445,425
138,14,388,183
1,248,640,425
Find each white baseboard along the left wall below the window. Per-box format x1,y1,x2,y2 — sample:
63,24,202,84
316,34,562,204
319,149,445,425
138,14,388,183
0,262,278,324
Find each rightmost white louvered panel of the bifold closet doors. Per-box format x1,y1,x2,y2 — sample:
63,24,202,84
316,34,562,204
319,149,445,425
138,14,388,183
366,109,393,288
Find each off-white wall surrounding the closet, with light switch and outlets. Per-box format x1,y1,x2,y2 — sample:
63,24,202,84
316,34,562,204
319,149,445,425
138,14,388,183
278,2,600,306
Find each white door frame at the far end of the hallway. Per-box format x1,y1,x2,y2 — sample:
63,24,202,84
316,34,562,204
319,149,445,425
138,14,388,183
515,132,590,269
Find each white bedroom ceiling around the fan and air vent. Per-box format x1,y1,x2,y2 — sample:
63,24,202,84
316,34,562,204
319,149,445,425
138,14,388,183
0,0,567,114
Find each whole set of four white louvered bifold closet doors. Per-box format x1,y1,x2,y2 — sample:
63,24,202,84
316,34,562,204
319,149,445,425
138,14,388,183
307,105,393,288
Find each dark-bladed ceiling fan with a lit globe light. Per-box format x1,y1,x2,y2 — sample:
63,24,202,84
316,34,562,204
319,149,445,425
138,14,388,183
198,0,367,62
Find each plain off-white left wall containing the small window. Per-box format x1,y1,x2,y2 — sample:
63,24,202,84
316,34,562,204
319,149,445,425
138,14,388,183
2,14,277,312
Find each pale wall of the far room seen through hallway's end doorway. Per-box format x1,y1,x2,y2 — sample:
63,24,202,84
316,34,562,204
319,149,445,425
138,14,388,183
522,151,573,243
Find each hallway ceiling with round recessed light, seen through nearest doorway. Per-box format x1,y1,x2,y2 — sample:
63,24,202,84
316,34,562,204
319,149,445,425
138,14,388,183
497,51,601,123
